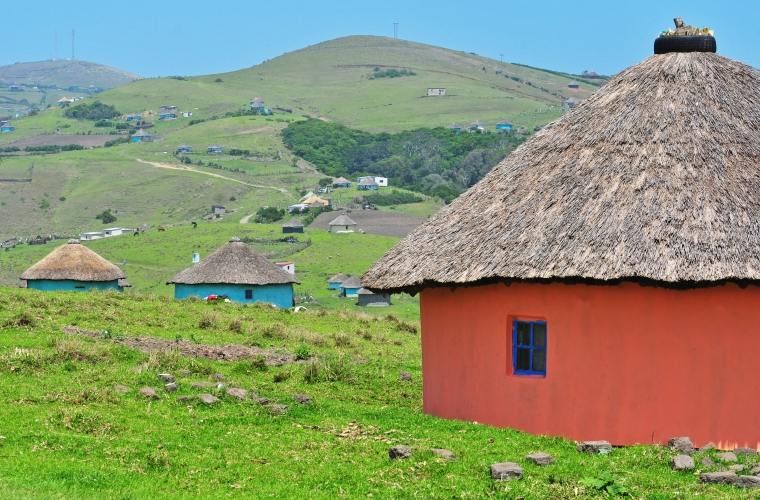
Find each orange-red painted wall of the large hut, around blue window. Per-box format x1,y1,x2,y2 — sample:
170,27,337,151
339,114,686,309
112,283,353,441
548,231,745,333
420,283,760,449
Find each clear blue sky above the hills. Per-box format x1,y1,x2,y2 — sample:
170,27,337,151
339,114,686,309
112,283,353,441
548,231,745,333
0,0,760,77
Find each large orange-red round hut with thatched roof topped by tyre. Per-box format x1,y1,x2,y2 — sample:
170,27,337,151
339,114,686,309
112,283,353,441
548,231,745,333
362,26,760,449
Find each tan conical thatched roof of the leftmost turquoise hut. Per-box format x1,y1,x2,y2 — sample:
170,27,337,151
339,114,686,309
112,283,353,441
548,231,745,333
20,240,127,281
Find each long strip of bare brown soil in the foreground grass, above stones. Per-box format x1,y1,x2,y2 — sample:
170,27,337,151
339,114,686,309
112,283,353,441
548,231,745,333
63,326,296,366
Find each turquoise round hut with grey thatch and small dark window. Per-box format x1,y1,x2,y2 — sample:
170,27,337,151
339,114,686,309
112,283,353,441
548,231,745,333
166,238,301,308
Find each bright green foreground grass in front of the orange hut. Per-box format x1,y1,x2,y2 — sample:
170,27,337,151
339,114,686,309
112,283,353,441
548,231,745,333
0,289,758,500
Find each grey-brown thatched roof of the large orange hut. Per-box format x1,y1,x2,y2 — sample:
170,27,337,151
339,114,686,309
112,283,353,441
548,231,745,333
362,52,760,292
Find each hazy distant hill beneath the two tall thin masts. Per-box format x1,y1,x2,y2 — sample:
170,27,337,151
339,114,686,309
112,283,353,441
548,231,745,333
0,59,142,89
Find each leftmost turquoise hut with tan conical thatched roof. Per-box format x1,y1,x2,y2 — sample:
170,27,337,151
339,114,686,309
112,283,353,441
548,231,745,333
20,240,130,292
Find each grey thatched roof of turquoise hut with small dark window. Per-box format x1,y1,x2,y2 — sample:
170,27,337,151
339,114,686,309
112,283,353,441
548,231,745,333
166,238,301,285
